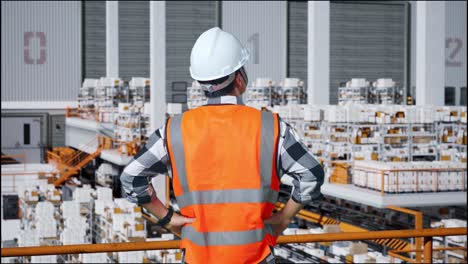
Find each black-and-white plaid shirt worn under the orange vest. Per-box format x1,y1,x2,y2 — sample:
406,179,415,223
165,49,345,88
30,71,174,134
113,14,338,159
120,96,324,204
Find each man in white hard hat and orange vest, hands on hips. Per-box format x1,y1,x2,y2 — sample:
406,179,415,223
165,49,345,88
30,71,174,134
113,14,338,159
121,27,324,263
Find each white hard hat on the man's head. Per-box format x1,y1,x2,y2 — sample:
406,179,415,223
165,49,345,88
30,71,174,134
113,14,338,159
190,27,249,81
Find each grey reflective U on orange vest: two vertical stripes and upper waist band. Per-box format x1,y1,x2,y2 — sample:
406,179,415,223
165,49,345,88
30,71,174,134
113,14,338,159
169,111,278,208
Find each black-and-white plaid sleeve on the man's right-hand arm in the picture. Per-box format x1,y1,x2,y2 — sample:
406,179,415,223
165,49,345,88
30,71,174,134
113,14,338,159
277,116,325,204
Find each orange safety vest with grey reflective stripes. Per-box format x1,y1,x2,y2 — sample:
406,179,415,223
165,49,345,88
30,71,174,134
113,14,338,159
166,105,280,263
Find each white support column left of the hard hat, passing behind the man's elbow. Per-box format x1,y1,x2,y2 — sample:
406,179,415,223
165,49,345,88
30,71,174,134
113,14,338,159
150,1,166,204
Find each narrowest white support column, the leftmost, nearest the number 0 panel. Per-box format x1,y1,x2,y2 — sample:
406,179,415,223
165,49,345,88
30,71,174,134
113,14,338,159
106,1,119,78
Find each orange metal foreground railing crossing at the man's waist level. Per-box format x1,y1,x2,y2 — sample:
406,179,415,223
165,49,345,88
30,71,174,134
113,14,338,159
2,228,467,263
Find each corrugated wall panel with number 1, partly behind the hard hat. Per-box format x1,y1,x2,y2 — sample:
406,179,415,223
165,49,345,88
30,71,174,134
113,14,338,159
221,1,288,82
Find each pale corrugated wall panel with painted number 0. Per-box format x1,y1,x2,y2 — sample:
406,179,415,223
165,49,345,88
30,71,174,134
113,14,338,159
1,1,81,110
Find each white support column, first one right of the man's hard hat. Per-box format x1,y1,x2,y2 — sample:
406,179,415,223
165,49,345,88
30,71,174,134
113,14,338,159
307,1,330,105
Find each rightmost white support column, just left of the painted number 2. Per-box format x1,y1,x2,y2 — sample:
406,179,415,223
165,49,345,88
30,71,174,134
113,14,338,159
415,1,445,105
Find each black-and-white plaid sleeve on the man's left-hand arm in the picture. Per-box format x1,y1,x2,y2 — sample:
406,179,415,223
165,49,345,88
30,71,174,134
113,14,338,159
120,126,170,204
